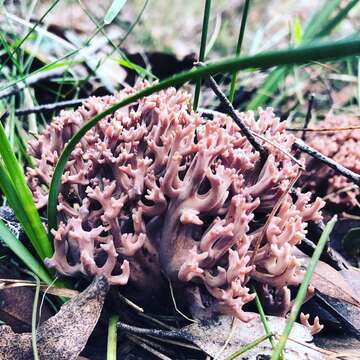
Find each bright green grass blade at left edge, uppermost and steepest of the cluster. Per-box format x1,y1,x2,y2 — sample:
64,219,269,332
0,123,53,260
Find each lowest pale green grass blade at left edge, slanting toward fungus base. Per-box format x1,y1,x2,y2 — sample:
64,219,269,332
0,219,52,284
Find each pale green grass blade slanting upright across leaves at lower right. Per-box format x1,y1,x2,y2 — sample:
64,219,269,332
271,216,337,360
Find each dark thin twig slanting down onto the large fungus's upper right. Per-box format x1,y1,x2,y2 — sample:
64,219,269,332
208,76,268,162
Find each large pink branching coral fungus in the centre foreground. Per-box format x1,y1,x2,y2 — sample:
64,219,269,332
28,85,323,321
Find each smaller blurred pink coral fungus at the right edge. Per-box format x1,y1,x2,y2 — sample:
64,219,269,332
303,112,360,207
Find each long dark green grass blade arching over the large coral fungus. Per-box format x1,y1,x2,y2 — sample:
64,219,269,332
47,39,360,235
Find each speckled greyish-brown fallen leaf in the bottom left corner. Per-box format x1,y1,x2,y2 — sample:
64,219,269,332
0,277,109,360
